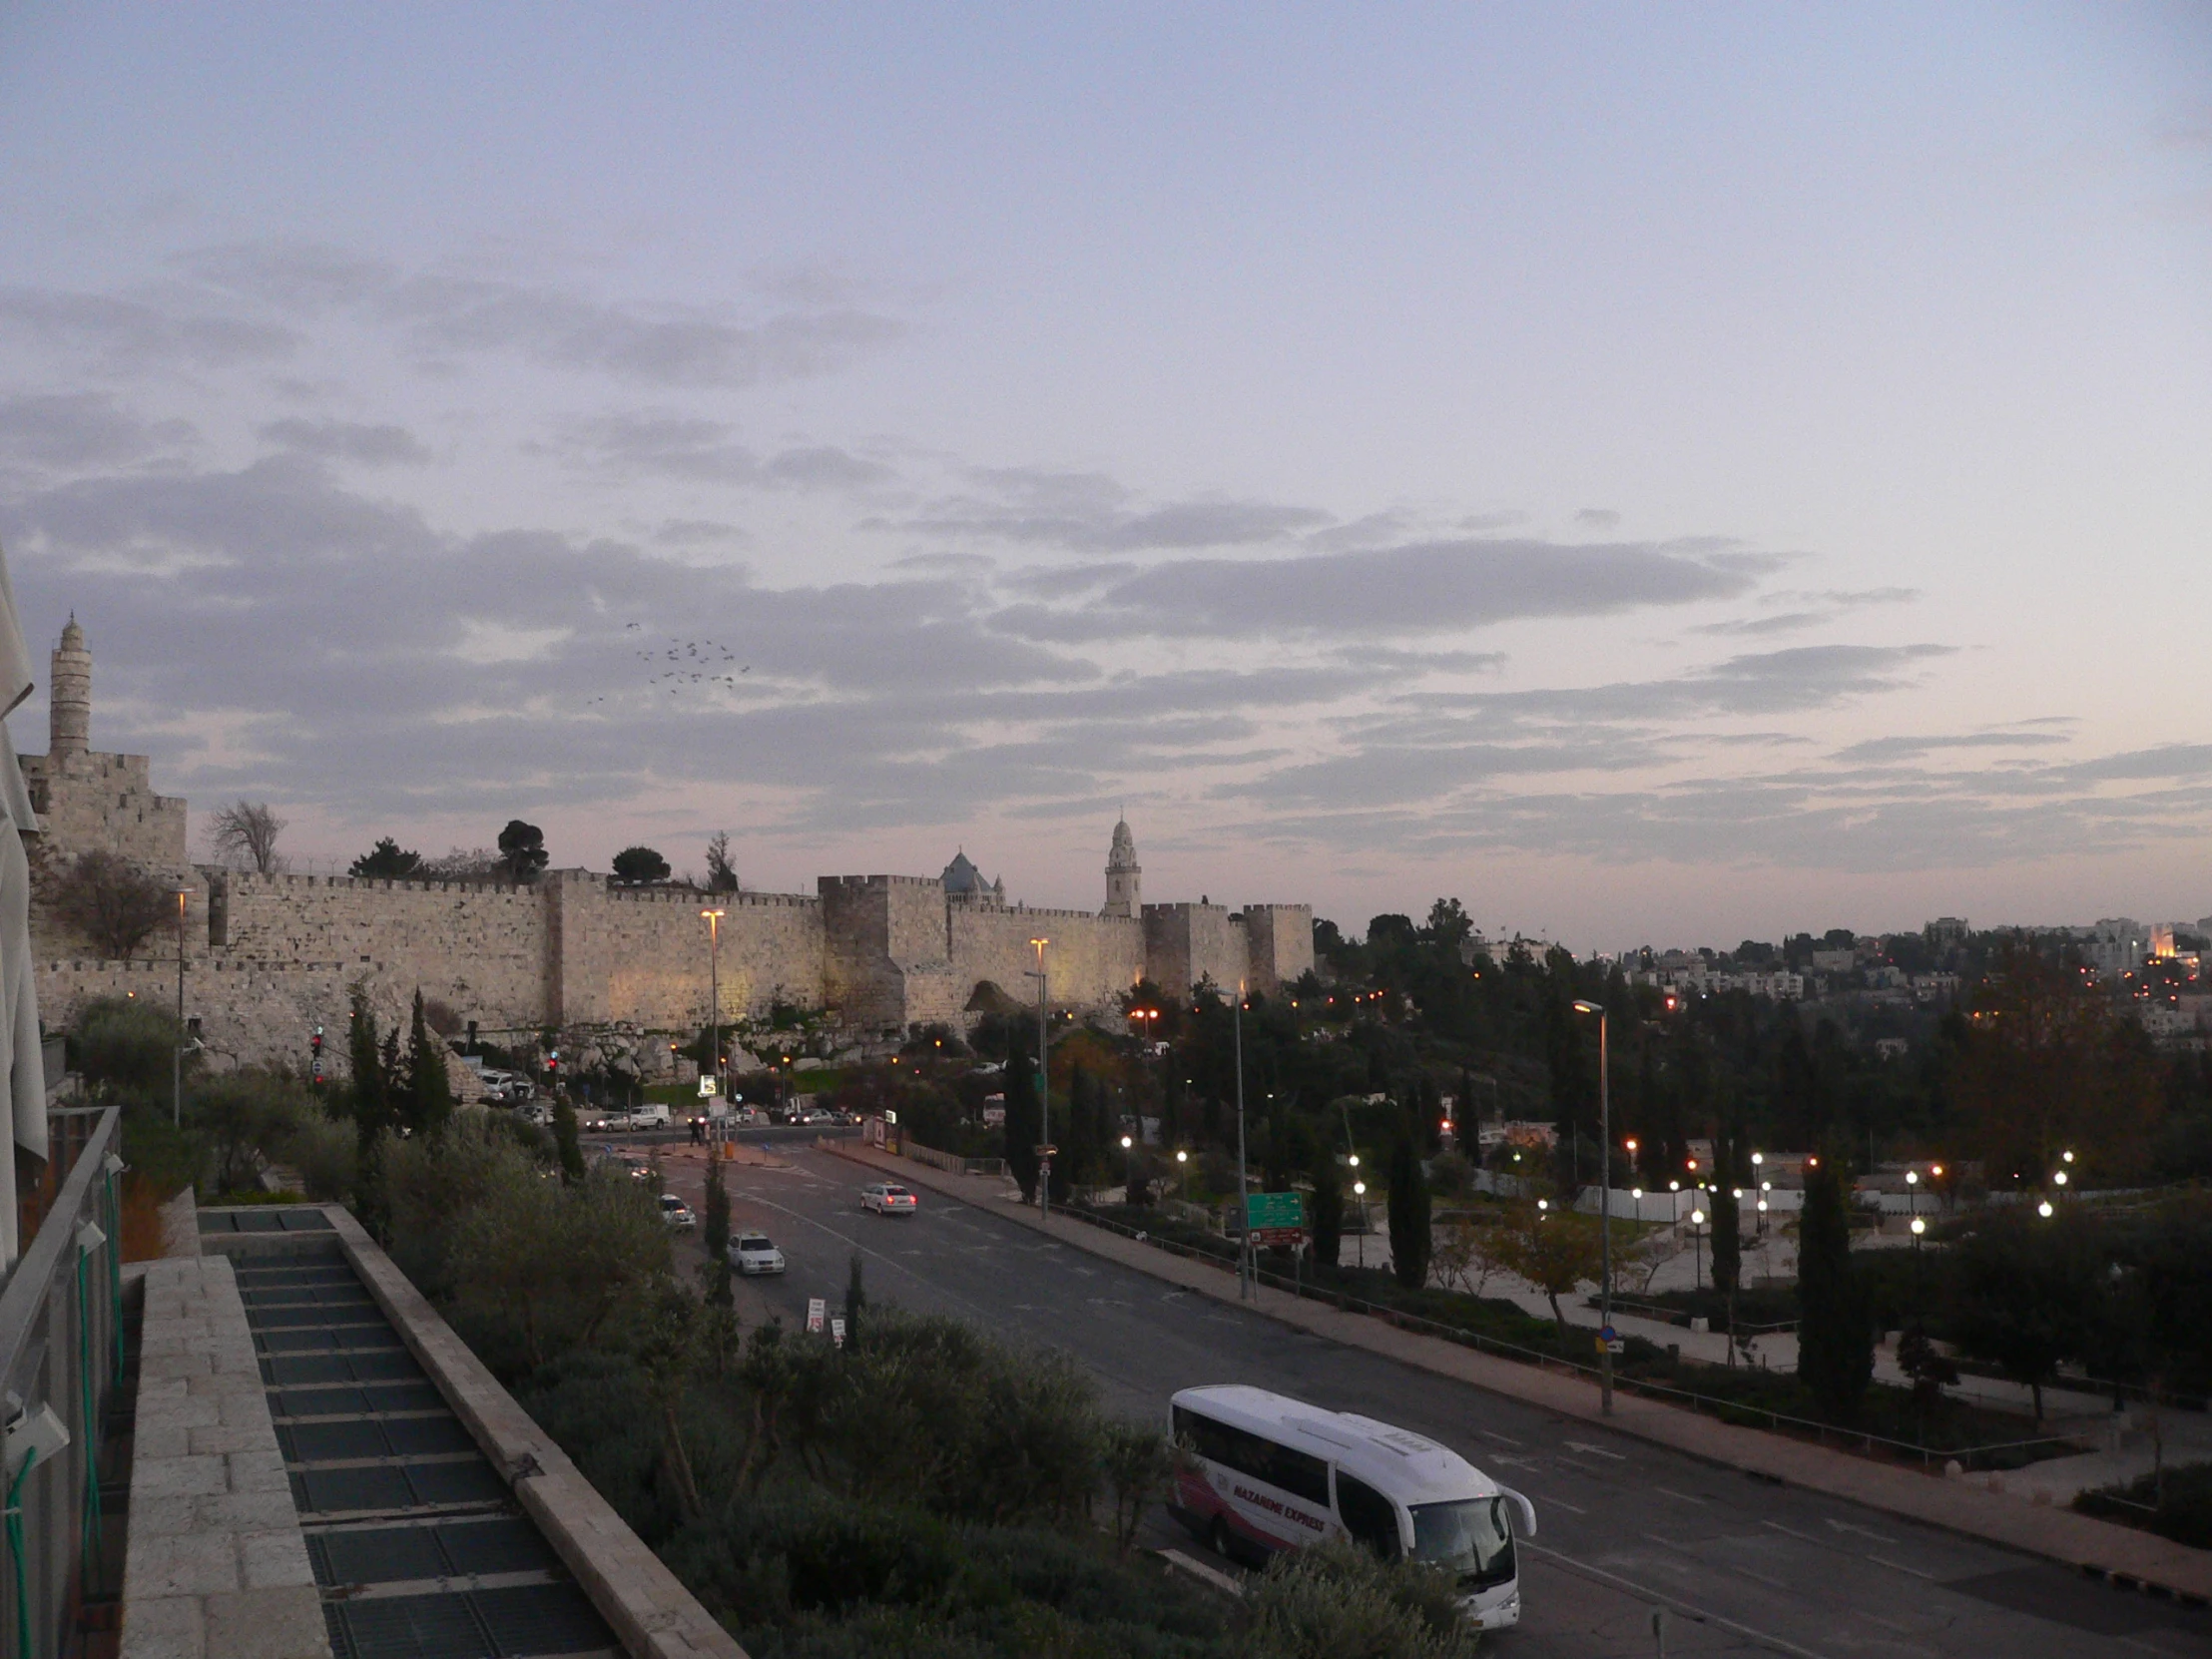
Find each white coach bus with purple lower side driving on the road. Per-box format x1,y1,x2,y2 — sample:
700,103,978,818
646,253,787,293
1168,1384,1535,1630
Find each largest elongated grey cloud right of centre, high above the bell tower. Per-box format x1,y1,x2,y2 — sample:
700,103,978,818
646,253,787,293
995,540,1752,642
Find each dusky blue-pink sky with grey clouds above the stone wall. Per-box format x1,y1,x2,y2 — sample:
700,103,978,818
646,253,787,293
0,2,2212,949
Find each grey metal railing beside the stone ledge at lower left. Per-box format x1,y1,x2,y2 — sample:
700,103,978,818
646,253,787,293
0,1106,124,1659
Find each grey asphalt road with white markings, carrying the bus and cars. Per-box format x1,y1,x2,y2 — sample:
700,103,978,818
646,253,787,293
662,1146,2212,1659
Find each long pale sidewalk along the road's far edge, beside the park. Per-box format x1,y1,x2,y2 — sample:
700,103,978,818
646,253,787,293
817,1141,2212,1599
